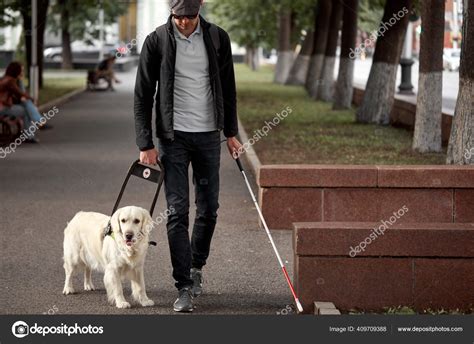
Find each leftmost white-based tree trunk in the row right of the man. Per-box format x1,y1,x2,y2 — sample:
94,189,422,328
274,6,294,84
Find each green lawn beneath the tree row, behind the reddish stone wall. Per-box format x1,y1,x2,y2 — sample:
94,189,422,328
235,64,446,165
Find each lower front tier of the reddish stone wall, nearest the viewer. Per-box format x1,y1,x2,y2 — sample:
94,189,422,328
293,222,474,313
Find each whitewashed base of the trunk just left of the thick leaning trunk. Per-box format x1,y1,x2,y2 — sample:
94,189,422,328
333,57,354,110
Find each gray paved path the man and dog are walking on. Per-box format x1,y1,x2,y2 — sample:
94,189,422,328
0,70,292,314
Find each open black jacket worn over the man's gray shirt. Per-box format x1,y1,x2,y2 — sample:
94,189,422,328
134,16,238,151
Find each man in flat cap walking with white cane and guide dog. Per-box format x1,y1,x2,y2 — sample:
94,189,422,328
135,0,241,312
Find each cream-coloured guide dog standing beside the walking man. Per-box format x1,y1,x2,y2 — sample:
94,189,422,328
63,206,154,308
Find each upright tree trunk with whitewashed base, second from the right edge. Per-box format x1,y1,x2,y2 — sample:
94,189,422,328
413,0,445,153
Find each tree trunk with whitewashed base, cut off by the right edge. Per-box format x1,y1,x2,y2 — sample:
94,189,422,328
446,0,474,165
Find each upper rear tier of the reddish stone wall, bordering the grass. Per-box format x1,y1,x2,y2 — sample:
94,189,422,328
258,165,474,230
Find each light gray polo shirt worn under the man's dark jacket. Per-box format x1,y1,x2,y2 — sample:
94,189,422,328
172,20,217,132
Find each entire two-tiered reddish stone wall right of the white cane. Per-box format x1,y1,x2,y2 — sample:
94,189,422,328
257,165,474,313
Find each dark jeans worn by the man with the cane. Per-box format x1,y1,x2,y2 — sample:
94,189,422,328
159,130,221,289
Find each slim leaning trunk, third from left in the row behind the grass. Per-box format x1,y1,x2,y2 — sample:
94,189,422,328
305,0,332,98
